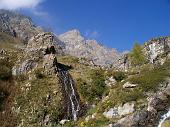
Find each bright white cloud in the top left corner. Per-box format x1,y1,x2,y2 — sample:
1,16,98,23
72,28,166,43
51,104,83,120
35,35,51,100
0,0,44,10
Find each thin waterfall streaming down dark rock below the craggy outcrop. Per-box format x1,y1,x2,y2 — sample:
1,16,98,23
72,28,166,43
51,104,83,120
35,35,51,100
58,69,80,121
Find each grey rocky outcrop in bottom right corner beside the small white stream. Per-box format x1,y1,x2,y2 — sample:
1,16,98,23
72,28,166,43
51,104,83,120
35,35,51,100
114,80,170,127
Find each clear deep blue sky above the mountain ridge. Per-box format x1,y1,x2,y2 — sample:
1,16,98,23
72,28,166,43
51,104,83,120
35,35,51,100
2,0,170,51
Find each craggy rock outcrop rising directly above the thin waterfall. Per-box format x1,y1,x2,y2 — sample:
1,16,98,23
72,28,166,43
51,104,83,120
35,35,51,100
13,33,62,75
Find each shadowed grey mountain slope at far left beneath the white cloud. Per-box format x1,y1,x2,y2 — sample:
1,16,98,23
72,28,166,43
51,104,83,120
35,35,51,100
0,10,42,43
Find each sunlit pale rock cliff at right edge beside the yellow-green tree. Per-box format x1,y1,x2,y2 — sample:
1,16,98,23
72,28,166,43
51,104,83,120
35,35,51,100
144,37,170,63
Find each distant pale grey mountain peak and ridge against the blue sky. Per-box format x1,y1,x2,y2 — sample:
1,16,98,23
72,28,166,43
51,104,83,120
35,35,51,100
59,30,120,66
